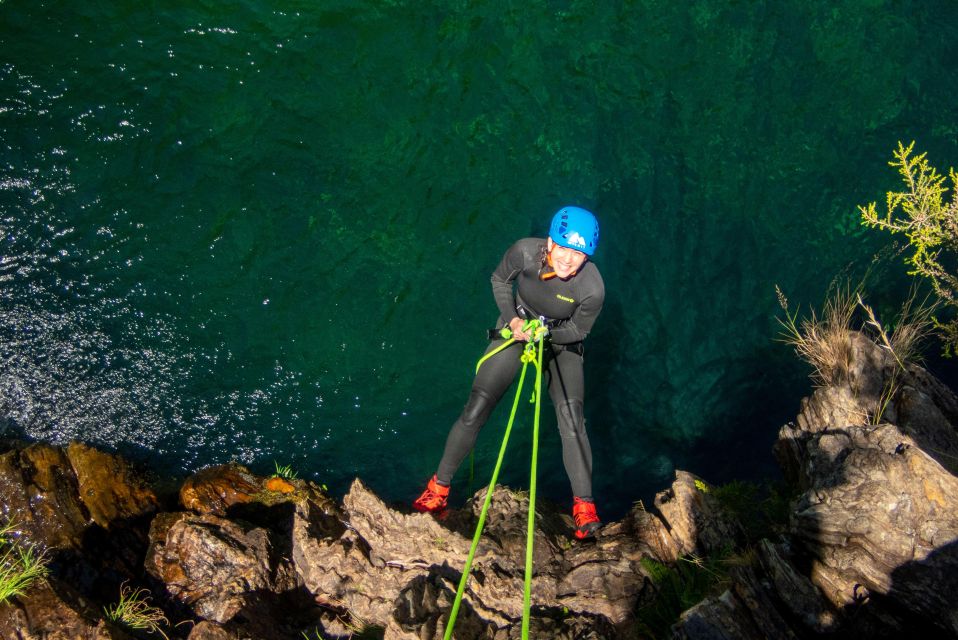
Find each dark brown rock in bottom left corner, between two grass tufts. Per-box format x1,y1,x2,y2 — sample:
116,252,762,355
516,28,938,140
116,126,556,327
0,578,132,640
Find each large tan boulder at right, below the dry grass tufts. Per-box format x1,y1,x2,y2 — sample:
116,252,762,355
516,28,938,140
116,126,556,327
775,334,958,634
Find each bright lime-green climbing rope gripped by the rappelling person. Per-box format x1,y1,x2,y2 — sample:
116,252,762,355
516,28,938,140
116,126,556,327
443,318,549,640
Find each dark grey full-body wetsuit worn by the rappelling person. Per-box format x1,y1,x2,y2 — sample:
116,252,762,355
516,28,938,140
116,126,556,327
436,238,605,500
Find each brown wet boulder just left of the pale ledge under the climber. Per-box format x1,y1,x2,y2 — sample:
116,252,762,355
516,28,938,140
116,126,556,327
144,513,297,623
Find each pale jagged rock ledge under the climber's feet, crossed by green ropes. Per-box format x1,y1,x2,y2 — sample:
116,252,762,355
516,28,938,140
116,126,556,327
293,480,665,638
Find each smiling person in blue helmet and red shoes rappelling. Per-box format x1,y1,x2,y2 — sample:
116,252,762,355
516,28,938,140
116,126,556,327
413,206,605,539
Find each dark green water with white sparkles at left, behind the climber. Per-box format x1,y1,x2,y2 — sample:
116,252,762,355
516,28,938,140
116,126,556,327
0,0,958,516
